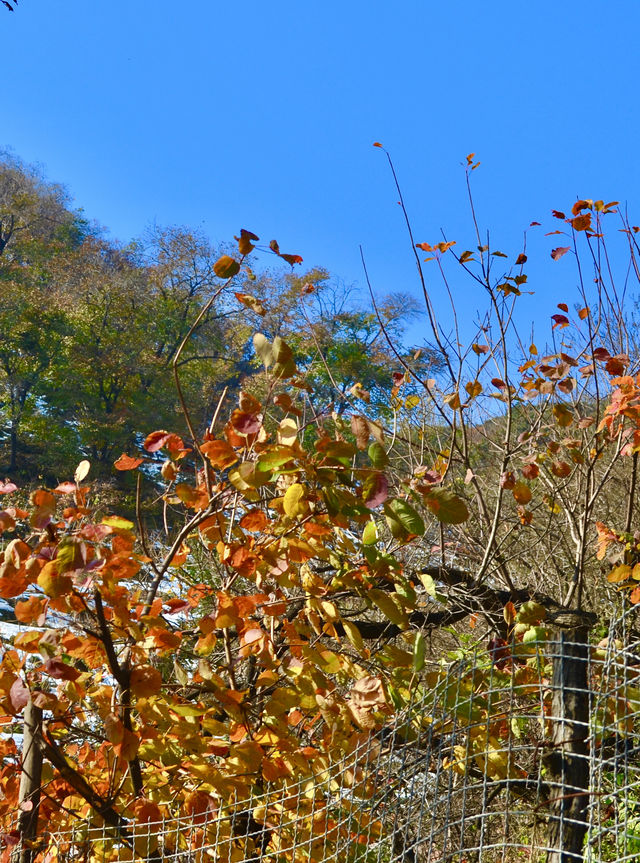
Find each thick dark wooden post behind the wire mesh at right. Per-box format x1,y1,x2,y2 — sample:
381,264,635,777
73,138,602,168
545,626,589,863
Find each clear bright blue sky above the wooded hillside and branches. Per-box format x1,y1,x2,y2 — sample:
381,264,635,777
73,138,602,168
5,0,640,348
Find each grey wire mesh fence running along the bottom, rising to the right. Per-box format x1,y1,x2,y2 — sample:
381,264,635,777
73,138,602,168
7,612,640,863
